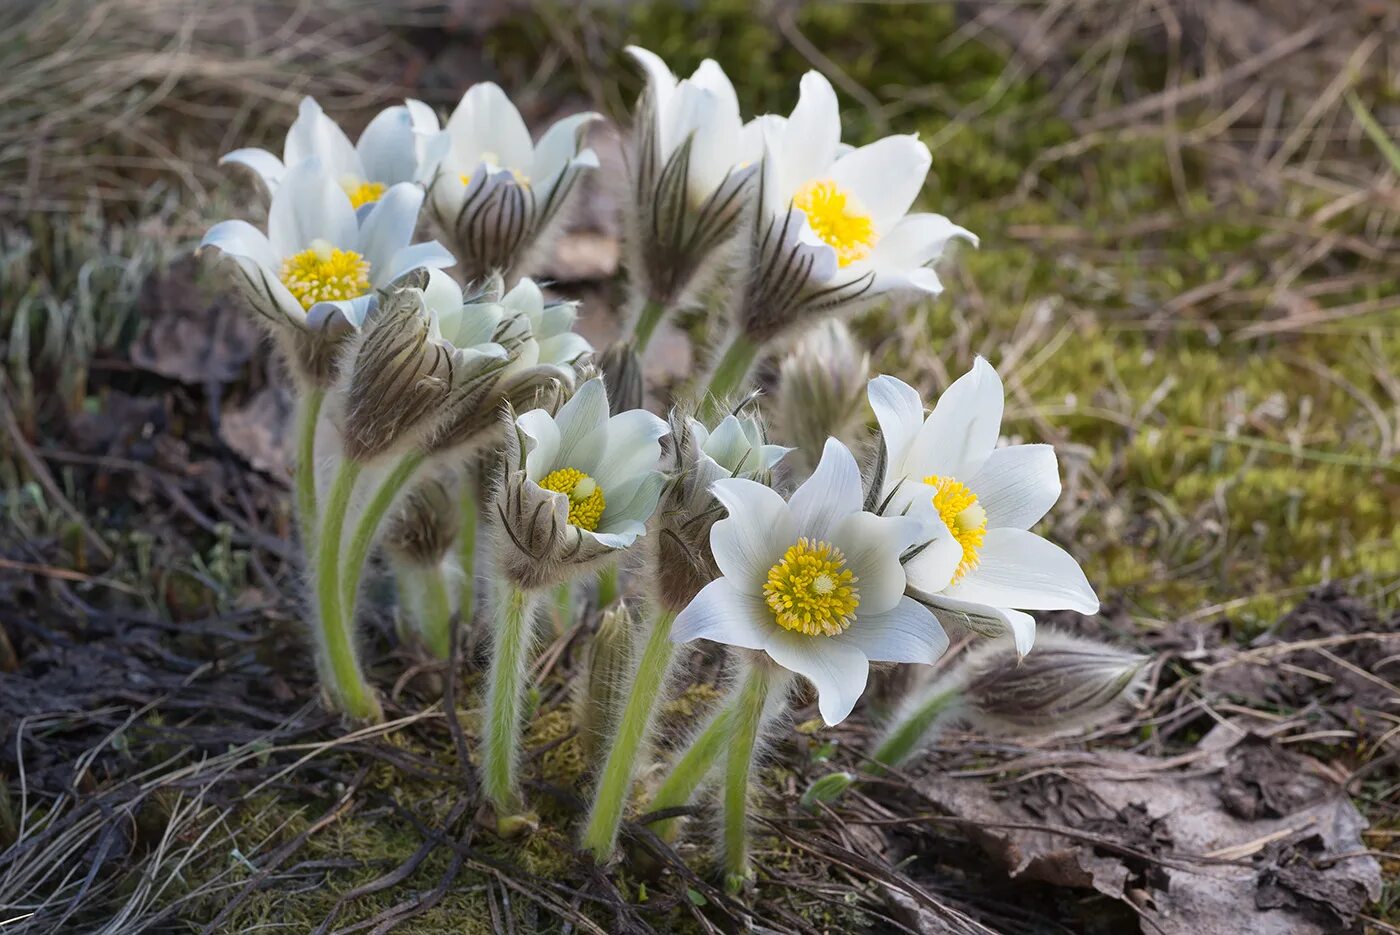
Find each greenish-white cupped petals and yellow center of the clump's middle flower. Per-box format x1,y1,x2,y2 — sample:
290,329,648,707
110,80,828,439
515,379,666,549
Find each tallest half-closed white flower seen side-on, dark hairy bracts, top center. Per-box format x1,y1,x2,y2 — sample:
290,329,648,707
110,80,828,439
627,46,762,307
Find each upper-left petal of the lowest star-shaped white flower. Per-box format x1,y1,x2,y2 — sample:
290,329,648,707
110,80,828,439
710,477,797,593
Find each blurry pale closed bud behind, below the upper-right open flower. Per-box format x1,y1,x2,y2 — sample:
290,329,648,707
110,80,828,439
776,319,871,473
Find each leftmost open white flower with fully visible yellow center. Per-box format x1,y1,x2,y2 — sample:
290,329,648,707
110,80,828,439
200,158,454,330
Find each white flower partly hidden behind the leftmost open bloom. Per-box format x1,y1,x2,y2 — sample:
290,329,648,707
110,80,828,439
218,97,438,209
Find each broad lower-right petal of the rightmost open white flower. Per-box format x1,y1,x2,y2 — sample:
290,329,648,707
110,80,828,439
948,529,1099,613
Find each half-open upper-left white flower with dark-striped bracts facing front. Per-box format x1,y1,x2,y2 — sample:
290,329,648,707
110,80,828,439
424,81,599,280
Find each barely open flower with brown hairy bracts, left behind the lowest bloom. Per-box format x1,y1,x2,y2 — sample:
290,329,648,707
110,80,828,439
652,406,792,613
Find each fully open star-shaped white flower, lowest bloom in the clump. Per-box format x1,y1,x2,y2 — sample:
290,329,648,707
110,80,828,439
672,438,948,724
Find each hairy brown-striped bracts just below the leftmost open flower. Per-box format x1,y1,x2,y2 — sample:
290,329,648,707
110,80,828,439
337,270,508,462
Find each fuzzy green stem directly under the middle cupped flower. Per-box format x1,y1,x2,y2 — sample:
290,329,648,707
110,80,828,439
482,582,536,819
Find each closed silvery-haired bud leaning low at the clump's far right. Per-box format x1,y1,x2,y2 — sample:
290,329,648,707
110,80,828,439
949,630,1148,733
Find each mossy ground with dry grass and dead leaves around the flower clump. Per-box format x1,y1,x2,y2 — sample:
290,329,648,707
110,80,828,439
0,0,1400,932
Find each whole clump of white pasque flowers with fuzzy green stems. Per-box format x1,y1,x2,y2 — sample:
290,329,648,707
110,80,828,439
203,54,1145,890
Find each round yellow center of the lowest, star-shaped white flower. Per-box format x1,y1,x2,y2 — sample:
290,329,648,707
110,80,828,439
763,536,861,637
